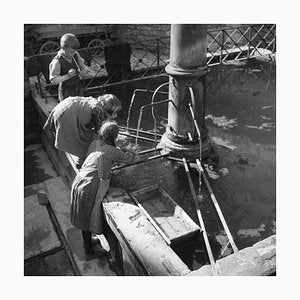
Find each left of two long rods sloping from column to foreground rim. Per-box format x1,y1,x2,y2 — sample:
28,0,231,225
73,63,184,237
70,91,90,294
182,158,218,275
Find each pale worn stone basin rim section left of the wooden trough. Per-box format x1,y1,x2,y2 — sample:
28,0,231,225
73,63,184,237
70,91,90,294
103,188,190,276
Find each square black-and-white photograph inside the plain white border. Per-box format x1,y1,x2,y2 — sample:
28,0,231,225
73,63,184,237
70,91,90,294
24,24,276,276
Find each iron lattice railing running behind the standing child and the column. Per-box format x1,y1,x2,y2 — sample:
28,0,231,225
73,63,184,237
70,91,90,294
30,24,276,96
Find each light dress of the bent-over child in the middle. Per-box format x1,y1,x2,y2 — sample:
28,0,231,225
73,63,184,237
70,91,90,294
44,97,105,158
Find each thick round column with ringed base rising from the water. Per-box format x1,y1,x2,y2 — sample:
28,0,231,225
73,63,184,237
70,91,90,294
160,24,211,159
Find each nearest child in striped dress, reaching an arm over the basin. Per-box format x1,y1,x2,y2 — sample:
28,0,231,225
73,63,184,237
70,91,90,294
71,121,135,255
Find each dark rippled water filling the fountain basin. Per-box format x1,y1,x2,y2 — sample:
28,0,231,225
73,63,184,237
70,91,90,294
104,60,276,269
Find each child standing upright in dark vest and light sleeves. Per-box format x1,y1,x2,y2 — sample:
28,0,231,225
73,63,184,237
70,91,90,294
49,33,88,101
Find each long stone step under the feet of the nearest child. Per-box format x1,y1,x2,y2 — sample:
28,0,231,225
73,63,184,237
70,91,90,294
45,177,116,276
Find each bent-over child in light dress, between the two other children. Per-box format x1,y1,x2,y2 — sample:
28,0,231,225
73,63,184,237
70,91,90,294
44,94,121,168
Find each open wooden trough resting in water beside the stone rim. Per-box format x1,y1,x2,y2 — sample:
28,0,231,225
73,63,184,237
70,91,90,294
129,184,200,245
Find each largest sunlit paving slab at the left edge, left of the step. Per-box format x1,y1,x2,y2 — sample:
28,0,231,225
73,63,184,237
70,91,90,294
24,193,61,259
